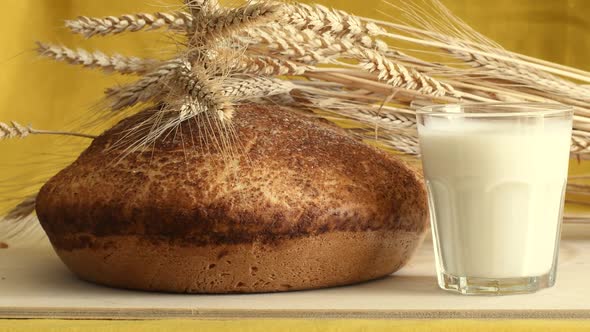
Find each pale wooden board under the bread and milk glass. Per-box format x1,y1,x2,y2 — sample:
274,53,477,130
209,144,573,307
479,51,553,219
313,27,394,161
0,238,590,319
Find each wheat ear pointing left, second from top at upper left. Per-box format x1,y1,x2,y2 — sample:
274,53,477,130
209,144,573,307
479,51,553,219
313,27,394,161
37,42,160,75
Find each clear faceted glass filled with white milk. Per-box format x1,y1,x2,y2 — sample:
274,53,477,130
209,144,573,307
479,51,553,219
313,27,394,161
417,103,573,295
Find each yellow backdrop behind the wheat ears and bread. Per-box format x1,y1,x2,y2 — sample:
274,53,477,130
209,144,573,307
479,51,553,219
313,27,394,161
0,0,590,210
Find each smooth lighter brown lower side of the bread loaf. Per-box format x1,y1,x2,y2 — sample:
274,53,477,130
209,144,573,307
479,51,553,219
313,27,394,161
57,231,421,293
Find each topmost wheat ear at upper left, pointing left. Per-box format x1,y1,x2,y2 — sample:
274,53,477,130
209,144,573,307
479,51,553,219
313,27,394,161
66,12,193,38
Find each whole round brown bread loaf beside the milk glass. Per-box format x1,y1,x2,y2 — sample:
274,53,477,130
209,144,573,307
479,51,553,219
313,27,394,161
37,105,427,293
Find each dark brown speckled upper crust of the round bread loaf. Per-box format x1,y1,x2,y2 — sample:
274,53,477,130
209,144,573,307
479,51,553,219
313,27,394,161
37,105,427,250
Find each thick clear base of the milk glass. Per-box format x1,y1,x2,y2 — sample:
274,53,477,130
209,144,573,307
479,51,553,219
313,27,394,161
438,269,555,295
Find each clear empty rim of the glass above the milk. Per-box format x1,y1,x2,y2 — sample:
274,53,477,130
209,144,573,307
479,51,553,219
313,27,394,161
416,102,573,118
